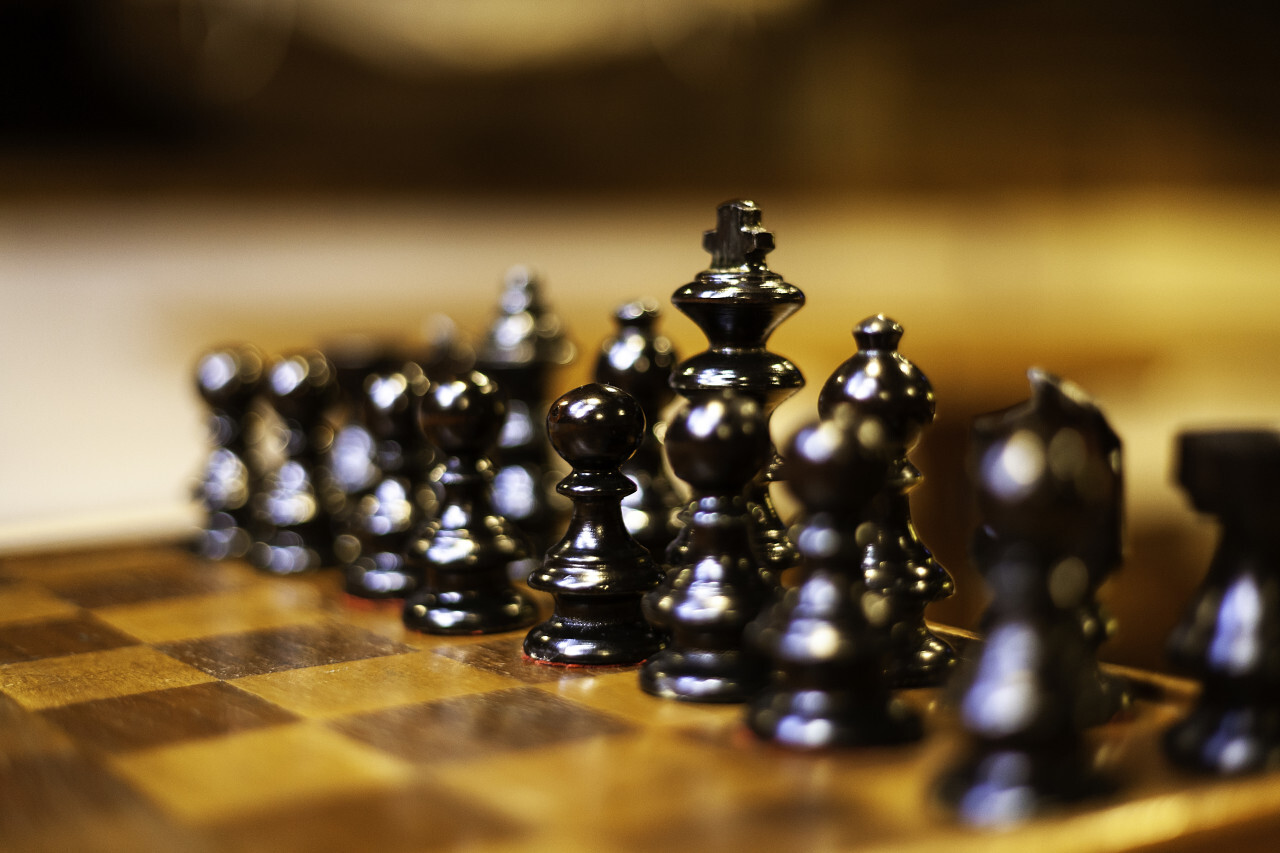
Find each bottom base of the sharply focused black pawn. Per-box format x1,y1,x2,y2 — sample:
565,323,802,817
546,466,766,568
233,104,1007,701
525,598,663,666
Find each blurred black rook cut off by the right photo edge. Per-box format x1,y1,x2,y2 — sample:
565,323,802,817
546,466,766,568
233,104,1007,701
1164,430,1280,776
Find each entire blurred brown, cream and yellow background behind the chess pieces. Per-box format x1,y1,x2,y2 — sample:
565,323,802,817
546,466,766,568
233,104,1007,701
0,0,1280,666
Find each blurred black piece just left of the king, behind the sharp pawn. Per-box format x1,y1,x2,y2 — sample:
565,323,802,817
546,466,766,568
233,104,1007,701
595,300,680,560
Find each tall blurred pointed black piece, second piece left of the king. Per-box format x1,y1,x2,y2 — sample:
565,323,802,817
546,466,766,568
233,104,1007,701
476,266,575,553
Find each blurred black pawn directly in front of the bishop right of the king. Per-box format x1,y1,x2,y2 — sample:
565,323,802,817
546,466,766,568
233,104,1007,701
746,406,923,749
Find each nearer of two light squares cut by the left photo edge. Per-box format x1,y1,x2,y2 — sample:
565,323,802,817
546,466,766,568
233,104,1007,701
0,646,214,711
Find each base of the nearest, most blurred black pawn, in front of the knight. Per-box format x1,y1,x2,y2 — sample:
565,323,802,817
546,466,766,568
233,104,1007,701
938,743,1115,827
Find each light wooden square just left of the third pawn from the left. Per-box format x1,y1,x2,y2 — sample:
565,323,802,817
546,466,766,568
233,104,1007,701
93,583,326,643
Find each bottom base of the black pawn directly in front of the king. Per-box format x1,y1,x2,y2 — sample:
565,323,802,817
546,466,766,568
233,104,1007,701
640,648,769,703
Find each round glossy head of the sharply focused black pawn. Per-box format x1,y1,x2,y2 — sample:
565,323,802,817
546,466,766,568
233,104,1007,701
547,382,645,470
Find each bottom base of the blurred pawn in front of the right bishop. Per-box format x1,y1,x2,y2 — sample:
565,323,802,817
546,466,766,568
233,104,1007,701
746,690,924,749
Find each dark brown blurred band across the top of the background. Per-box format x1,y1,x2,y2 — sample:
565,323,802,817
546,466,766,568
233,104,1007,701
0,0,1280,192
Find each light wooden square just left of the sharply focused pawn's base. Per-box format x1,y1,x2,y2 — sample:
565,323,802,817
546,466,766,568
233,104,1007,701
236,653,516,719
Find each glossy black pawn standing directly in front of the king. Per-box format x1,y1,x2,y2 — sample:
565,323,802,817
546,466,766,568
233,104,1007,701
640,391,773,702
